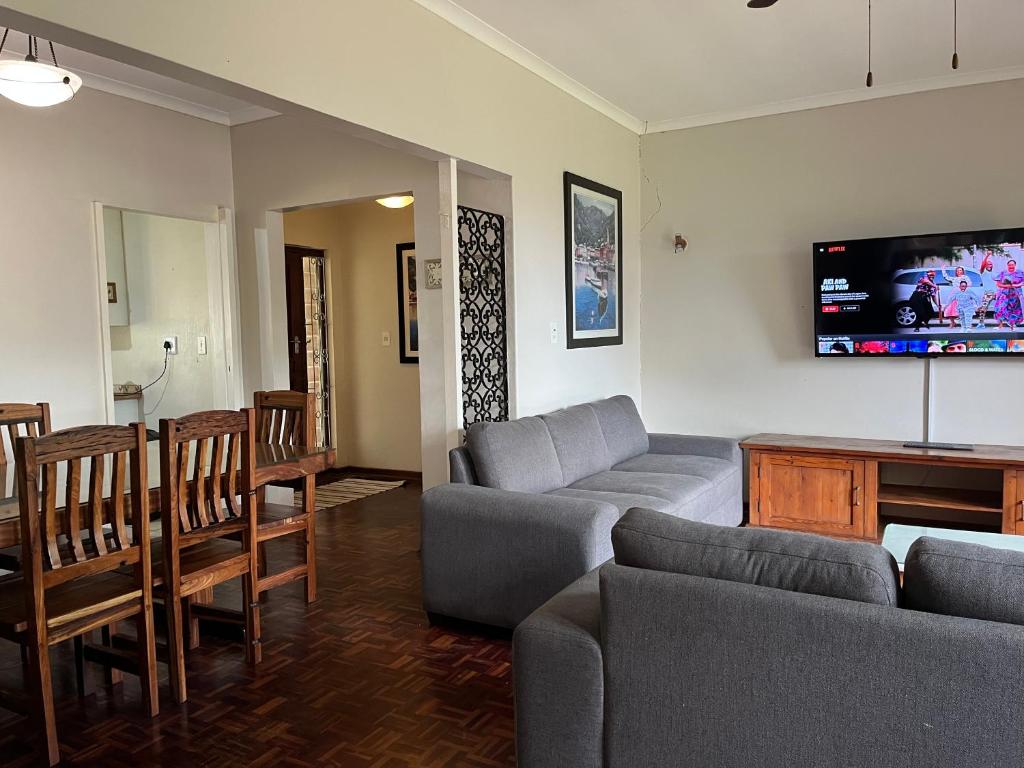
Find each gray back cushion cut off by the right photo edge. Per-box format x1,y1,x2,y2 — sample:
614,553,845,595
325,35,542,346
903,537,1024,625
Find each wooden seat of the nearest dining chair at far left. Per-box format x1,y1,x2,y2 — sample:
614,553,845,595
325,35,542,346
0,571,142,637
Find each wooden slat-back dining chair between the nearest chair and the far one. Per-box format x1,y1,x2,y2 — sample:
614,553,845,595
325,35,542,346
154,409,262,703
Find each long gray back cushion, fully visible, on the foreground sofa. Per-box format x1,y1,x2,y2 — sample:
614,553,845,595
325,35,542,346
611,509,899,605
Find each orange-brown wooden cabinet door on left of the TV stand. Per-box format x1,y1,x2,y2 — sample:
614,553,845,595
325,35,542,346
758,455,864,538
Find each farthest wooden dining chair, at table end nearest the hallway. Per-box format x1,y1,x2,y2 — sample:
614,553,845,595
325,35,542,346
253,389,316,603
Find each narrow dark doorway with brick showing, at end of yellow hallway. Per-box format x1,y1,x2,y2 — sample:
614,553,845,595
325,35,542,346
285,245,332,445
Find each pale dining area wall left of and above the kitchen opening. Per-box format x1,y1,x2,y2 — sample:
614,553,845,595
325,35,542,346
0,88,232,428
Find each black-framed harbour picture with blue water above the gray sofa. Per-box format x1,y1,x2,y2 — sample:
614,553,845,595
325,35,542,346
563,172,623,349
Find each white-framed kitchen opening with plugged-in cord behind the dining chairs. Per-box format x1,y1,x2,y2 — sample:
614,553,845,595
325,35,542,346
94,204,239,430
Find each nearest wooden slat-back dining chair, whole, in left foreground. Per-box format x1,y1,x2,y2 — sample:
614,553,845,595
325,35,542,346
0,424,159,766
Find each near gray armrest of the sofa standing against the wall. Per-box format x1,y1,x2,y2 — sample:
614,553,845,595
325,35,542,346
420,484,618,627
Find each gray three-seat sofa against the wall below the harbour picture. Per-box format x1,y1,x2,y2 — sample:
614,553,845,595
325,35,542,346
421,395,742,627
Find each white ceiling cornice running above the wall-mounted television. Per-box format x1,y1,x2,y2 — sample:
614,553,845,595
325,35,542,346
646,67,1024,133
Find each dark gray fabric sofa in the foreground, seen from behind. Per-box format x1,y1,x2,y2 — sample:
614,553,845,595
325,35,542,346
513,510,1024,768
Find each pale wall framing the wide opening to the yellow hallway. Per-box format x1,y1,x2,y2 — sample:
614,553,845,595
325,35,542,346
231,117,449,485
